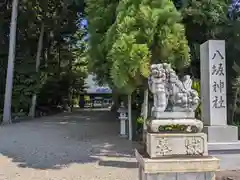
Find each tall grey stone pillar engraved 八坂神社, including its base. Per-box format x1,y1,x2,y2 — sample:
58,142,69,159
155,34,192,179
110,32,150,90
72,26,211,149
200,40,240,150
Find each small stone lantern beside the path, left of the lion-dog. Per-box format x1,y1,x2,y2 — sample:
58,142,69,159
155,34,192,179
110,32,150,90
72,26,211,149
118,102,128,137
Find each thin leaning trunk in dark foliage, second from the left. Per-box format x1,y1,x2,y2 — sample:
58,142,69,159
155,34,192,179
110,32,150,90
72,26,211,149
29,22,44,118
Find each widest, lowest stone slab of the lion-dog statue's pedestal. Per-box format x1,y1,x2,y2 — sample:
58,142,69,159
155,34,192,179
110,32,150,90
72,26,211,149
135,150,219,180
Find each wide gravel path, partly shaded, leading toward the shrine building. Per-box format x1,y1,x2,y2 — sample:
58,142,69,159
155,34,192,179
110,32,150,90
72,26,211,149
0,111,137,180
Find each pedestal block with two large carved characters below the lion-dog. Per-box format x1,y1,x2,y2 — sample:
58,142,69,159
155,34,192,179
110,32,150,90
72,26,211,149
146,133,208,158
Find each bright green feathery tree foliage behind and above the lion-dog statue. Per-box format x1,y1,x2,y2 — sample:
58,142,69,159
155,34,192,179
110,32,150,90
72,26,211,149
87,0,190,93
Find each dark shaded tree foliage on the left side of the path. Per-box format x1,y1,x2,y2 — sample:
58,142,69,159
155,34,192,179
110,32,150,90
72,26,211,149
0,0,86,113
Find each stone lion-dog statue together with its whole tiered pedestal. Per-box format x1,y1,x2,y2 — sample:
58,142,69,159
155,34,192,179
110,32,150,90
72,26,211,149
135,63,219,180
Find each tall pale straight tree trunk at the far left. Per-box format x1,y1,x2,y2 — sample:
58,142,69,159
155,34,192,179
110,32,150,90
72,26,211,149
3,0,19,124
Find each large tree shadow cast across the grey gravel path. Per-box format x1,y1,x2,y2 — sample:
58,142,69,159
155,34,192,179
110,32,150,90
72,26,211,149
0,111,137,170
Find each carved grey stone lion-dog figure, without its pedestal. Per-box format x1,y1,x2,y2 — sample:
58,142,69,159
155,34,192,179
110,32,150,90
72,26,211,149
148,63,200,112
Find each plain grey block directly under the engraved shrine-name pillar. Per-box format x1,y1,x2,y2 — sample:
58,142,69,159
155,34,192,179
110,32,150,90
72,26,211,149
203,126,238,143
